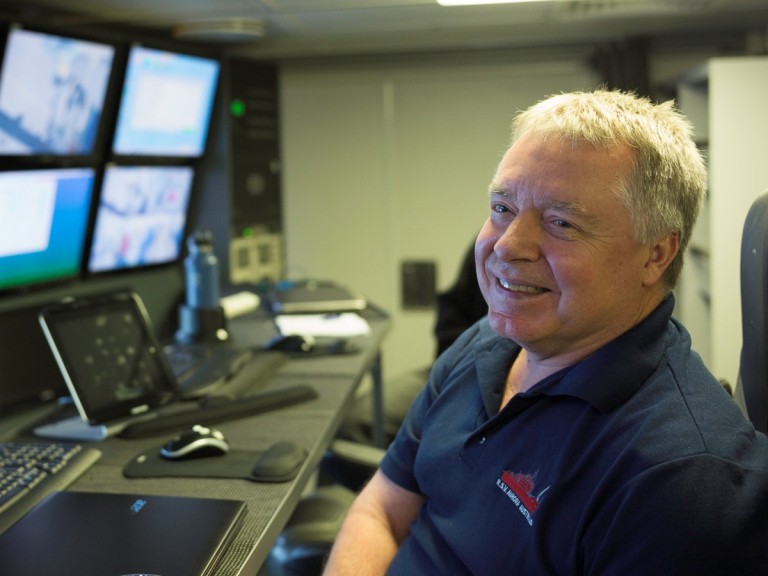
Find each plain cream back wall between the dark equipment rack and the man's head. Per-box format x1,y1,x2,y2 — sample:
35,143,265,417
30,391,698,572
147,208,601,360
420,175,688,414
280,53,598,375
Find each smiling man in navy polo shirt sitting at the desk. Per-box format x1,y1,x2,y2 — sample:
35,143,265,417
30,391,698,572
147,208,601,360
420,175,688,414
326,90,768,576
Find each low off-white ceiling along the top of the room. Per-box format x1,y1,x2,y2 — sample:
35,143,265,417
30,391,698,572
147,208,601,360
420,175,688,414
0,0,768,60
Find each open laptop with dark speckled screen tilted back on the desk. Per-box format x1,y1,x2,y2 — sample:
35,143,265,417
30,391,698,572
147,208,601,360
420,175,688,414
35,290,253,440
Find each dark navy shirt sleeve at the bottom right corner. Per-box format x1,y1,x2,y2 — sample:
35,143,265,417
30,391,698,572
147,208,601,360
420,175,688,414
581,454,768,576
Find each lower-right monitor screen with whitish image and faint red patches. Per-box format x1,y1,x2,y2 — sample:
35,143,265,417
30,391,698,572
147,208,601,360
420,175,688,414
88,165,193,272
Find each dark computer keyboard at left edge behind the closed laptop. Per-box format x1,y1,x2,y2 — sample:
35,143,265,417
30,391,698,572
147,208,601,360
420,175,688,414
0,440,101,534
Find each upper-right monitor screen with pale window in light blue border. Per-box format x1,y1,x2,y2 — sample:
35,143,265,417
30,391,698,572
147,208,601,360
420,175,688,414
112,46,219,158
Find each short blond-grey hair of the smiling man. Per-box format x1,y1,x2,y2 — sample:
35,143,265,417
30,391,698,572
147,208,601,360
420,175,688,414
512,89,707,288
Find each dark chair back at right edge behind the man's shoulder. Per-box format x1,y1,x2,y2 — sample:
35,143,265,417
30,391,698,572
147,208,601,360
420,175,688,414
736,190,768,432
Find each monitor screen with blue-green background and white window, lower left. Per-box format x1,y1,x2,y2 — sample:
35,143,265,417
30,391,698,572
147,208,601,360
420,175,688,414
0,168,94,289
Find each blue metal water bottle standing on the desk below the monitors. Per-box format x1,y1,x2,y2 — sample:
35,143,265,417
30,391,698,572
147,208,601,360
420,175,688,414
184,230,220,309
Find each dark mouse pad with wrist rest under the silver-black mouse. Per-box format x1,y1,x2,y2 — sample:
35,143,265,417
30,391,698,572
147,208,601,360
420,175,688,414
123,442,307,482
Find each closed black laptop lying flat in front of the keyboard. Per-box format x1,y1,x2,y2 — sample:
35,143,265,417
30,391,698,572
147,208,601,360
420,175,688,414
0,492,246,576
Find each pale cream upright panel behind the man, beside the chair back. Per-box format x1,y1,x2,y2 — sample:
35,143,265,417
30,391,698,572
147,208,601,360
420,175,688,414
709,57,768,383
